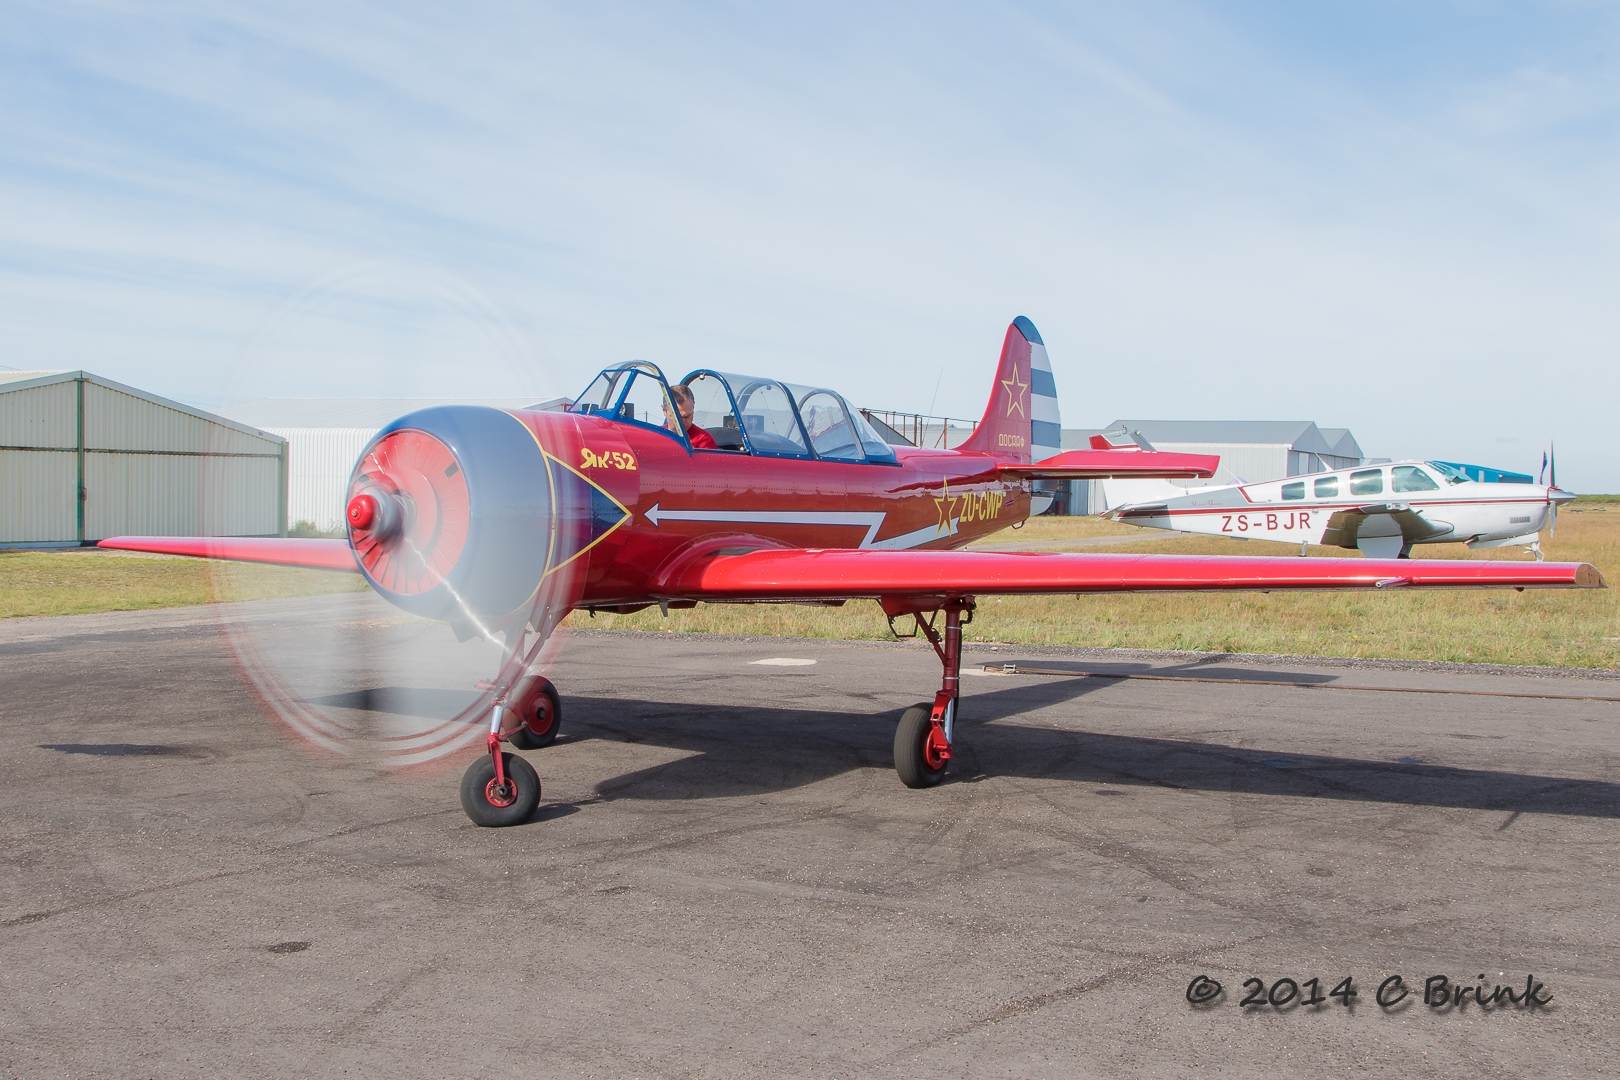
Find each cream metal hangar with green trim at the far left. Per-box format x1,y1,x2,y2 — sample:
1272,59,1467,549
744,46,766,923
0,371,287,547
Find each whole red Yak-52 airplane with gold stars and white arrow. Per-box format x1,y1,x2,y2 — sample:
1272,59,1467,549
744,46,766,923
102,317,1602,826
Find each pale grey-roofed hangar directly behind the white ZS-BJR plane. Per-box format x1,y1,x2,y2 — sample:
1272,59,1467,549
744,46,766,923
1059,419,1362,513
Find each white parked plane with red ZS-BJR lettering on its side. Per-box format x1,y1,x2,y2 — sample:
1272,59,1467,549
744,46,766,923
1102,461,1575,560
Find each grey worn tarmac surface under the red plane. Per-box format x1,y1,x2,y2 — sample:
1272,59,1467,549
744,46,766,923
0,594,1620,1078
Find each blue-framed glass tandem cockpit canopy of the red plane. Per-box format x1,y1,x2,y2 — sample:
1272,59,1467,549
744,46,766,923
570,361,897,465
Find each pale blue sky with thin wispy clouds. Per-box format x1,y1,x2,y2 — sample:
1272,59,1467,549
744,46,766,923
0,0,1620,491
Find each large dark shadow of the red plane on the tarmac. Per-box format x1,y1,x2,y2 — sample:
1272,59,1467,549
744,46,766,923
557,667,1620,818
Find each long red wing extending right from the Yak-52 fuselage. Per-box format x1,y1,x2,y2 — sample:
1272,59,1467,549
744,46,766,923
653,549,1604,601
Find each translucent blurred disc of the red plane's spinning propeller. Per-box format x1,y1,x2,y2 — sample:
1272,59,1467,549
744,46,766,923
198,261,582,769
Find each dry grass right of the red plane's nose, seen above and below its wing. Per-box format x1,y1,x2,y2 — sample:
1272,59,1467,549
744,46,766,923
567,499,1620,667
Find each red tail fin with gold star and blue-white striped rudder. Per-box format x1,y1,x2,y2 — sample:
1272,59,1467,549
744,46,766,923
957,316,1063,465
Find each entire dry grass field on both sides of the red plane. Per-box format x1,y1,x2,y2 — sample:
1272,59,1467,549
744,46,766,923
0,497,1620,667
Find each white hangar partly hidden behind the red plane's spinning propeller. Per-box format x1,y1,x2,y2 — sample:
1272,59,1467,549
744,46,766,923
219,398,567,533
